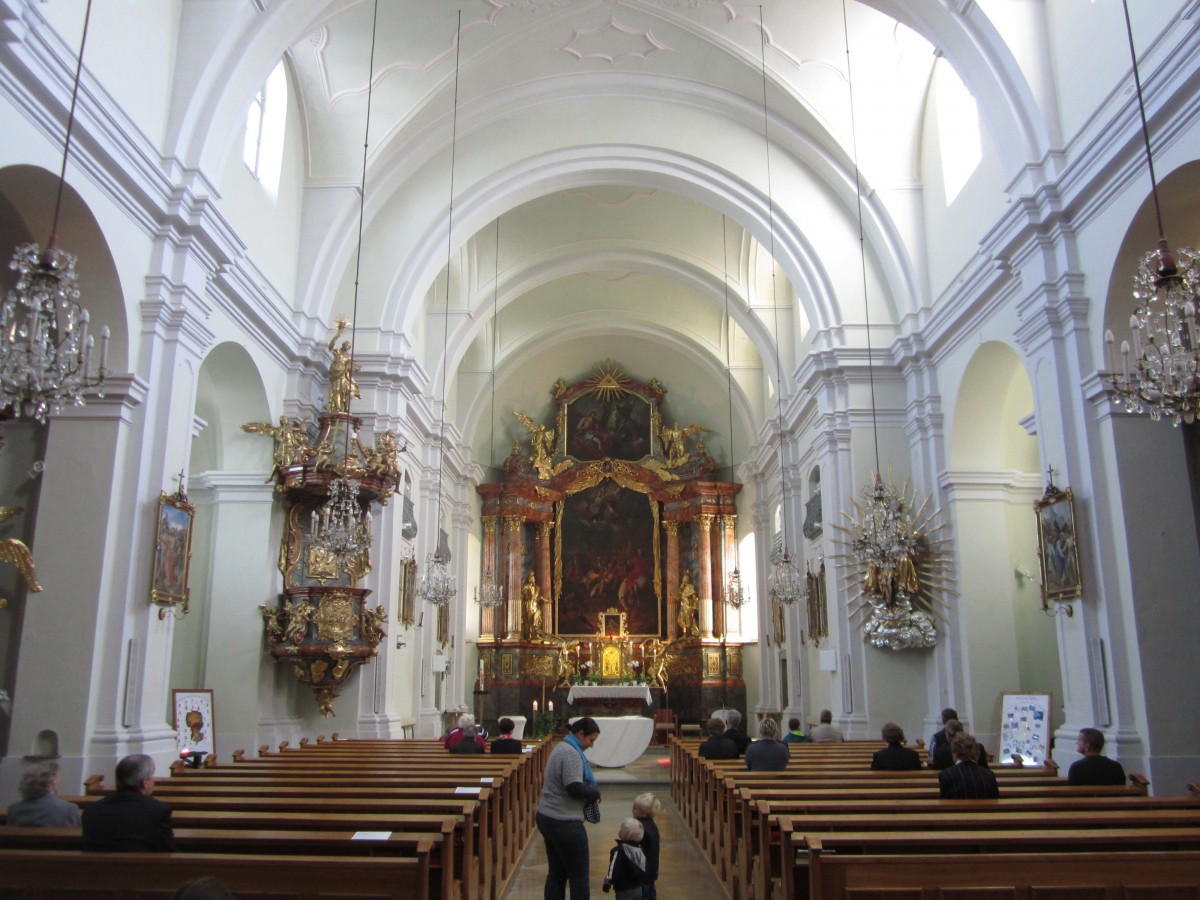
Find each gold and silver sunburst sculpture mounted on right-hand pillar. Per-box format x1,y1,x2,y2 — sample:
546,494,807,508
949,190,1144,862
834,474,954,650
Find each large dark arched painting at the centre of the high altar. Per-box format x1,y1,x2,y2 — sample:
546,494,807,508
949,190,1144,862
557,479,660,635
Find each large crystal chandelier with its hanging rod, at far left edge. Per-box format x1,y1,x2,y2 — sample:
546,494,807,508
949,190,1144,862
0,0,108,424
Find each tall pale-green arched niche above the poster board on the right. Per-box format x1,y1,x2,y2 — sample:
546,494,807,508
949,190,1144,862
950,342,1062,746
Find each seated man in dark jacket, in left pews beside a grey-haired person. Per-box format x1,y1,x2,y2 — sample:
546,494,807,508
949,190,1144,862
83,754,175,853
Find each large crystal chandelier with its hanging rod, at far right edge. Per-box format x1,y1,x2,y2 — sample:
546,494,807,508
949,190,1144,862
1100,2,1200,425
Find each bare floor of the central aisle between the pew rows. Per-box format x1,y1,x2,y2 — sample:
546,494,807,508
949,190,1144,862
504,748,725,900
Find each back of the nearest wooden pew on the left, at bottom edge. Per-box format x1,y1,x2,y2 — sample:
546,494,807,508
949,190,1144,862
0,850,428,900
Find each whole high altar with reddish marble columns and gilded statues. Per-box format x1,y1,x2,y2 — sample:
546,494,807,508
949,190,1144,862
476,362,745,722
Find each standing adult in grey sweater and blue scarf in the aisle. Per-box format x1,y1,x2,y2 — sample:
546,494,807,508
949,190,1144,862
538,715,600,900
